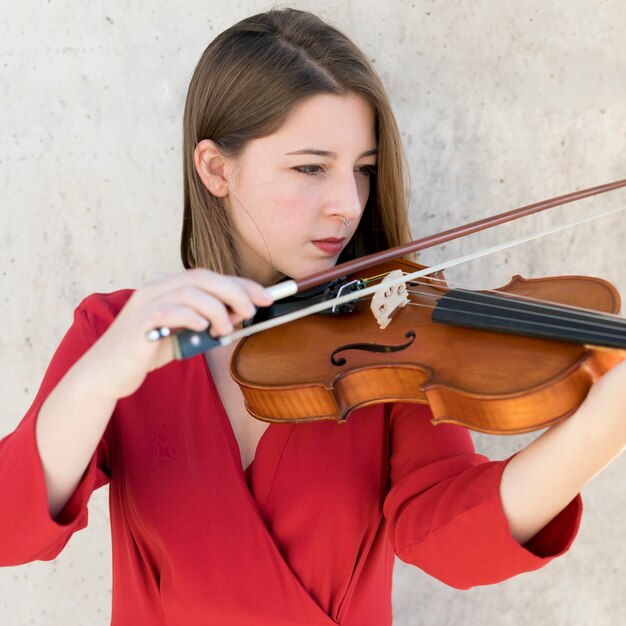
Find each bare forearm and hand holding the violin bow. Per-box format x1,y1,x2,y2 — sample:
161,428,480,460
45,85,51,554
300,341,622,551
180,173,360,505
36,269,272,517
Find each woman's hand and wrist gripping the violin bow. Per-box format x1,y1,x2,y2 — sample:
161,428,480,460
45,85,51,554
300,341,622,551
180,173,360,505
83,269,273,400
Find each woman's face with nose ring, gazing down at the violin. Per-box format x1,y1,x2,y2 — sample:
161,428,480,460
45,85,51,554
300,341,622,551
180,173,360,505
224,94,377,284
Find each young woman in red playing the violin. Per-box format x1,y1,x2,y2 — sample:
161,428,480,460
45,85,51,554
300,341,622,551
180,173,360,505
0,9,626,626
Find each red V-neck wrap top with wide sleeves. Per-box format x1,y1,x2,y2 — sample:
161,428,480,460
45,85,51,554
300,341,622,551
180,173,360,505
0,291,582,626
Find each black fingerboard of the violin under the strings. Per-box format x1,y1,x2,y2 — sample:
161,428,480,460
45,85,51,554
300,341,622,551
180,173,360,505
432,289,626,349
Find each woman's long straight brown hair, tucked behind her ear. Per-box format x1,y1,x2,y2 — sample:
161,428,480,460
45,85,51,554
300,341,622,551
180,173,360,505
181,9,410,274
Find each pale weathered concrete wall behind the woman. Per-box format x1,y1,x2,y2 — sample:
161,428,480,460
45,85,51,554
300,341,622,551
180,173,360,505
0,0,626,626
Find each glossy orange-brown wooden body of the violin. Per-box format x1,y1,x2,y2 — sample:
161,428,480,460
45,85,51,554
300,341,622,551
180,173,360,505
231,260,626,434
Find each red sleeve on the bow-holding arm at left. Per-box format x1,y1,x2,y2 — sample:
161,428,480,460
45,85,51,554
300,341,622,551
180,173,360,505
0,298,108,565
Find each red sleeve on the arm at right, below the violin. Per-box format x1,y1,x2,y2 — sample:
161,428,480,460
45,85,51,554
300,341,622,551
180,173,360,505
384,404,582,589
